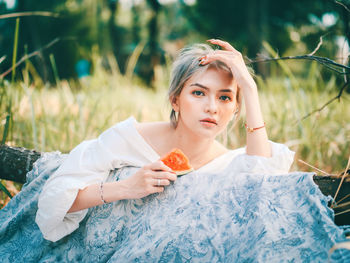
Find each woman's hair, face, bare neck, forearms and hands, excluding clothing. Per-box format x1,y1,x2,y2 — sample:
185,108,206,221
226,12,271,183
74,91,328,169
54,40,271,216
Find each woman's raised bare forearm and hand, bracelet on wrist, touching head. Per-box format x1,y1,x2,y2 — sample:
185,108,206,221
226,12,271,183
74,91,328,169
201,39,271,157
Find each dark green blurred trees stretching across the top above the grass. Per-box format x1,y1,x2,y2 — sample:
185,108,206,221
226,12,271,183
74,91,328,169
0,0,350,88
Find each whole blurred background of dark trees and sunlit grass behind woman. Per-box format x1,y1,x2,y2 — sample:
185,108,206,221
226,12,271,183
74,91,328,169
0,0,350,202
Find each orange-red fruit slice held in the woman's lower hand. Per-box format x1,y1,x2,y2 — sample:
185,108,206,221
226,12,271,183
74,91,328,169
161,148,193,176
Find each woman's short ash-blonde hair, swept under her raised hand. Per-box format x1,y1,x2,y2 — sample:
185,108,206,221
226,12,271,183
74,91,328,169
168,44,242,127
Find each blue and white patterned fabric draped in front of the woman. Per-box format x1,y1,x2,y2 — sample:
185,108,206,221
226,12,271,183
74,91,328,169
0,153,350,263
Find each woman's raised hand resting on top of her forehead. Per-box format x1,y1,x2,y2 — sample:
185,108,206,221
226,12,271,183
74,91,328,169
200,39,256,92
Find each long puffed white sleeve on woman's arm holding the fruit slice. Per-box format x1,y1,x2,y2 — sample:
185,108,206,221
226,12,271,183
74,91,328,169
35,118,144,241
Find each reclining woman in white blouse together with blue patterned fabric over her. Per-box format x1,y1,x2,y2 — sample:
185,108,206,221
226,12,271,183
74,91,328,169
0,40,348,262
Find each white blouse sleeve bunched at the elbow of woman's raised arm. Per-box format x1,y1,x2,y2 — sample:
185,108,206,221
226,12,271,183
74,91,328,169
230,141,295,175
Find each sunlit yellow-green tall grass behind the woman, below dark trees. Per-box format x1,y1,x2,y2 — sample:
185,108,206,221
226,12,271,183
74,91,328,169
0,48,350,207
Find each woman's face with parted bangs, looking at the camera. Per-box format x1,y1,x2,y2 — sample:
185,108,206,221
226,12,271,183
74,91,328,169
172,68,237,139
